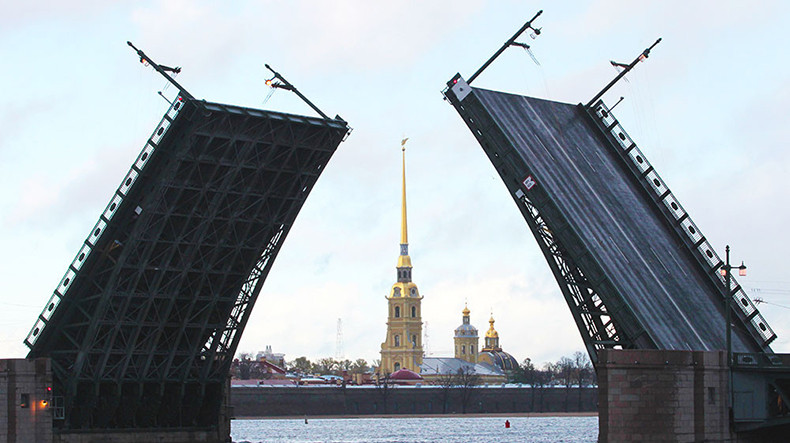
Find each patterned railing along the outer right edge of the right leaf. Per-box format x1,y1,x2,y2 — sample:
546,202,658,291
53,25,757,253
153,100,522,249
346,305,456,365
591,100,776,347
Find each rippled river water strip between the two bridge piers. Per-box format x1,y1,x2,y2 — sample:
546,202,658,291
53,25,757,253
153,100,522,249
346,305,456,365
231,416,598,443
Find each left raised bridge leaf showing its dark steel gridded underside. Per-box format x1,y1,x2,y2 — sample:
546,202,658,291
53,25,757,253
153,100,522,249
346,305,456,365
25,95,349,430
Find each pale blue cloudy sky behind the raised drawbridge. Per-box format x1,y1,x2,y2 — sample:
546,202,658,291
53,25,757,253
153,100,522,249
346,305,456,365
0,0,790,363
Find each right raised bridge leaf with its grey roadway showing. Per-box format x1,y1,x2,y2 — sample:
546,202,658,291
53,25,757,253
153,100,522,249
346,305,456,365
445,75,776,362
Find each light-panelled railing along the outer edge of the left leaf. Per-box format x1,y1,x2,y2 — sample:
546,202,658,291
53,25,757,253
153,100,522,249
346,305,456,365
24,96,184,348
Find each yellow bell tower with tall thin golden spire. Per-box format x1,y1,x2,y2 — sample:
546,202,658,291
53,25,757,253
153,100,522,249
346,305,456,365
377,139,423,375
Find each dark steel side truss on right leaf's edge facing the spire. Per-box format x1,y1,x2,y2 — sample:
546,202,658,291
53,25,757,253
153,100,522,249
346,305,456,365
444,75,656,364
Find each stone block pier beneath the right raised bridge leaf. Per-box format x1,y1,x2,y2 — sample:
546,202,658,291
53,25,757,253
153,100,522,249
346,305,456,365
597,349,766,443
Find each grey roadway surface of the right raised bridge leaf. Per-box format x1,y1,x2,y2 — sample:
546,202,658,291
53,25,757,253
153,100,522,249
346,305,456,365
470,88,761,352
